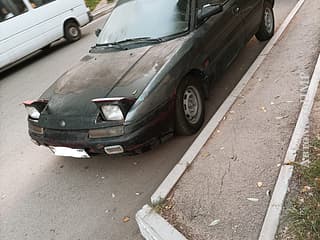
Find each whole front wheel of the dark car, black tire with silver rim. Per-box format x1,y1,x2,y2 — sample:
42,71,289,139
175,76,205,135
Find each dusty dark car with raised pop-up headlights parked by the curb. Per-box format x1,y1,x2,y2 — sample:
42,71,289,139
24,0,274,157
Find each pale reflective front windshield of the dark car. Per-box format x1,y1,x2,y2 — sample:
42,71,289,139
97,0,190,45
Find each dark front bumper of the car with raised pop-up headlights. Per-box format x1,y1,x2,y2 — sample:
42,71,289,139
29,102,174,153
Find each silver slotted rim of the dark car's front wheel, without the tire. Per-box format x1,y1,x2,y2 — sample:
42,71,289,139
183,86,202,124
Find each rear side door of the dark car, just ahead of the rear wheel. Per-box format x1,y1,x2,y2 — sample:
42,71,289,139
239,0,264,41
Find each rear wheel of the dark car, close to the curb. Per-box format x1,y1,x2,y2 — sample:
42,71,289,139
256,2,275,41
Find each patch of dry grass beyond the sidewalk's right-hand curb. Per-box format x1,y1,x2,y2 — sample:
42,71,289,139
287,140,320,240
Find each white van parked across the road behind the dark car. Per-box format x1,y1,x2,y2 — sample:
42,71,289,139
0,0,91,71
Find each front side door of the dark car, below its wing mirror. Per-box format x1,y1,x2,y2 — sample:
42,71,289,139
196,0,245,74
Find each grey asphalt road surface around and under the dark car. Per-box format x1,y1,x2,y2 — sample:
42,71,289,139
0,0,296,240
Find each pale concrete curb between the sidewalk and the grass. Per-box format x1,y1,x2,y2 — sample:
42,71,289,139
259,51,320,240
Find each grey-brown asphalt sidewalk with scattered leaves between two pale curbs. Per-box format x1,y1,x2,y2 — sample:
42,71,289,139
145,1,320,240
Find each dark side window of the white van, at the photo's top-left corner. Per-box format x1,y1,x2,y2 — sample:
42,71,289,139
0,0,28,22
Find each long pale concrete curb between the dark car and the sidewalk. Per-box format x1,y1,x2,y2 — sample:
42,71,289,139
151,0,304,205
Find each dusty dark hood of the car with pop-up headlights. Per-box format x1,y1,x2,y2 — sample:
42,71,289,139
41,38,184,128
